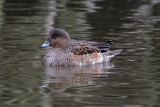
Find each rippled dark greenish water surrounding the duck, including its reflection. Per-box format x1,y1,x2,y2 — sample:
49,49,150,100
0,0,160,107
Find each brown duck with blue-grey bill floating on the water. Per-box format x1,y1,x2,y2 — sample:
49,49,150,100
40,28,123,66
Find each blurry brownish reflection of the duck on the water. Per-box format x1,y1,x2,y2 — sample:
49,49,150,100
41,62,114,97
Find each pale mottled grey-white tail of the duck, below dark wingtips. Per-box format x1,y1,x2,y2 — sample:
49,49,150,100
103,49,123,61
